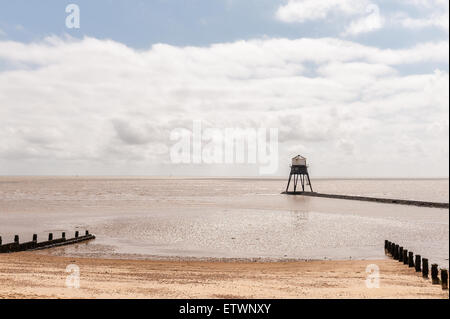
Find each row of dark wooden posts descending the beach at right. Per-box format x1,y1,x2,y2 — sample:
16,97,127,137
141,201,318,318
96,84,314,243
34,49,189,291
384,240,448,290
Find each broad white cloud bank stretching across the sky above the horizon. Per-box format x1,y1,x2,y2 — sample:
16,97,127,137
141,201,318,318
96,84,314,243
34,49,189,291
0,37,449,176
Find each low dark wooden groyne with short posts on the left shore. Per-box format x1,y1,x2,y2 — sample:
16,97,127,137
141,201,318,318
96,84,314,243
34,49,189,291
0,230,95,253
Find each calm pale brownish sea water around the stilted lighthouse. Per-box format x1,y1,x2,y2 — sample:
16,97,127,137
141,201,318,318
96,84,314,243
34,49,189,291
0,177,449,267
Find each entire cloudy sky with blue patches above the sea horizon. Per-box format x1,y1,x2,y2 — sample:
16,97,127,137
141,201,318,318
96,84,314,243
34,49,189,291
0,0,449,177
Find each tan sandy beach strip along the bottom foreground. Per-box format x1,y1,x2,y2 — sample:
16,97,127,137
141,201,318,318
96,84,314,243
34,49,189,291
0,252,448,298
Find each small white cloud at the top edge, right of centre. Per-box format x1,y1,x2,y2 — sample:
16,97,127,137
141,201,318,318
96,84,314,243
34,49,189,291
276,0,369,22
